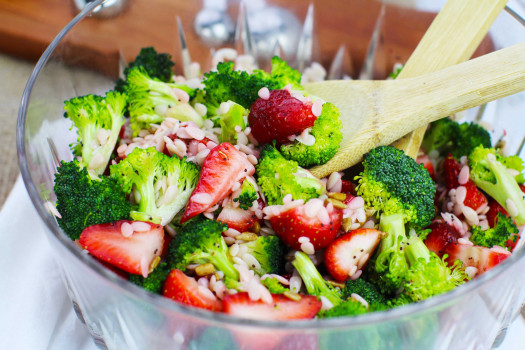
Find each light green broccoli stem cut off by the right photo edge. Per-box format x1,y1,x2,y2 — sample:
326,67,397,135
468,146,525,226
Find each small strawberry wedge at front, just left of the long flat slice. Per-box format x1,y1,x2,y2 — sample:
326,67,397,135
162,269,222,311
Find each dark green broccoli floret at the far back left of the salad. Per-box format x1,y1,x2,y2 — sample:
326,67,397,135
115,47,175,92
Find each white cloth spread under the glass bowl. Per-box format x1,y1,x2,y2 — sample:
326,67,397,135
0,178,525,350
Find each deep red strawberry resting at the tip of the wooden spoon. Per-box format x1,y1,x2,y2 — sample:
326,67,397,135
248,90,317,144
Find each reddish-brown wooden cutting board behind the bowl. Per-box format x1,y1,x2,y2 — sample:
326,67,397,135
0,0,492,78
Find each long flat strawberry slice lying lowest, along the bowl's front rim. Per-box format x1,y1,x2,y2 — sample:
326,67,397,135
223,292,322,321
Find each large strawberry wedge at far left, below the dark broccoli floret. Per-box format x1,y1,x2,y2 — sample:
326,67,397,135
79,220,164,277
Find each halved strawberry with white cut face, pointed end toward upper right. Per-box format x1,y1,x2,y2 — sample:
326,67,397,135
324,228,382,282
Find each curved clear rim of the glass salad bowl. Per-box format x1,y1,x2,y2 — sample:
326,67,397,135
16,0,525,330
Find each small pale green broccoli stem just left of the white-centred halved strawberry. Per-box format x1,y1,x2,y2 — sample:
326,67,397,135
292,252,342,306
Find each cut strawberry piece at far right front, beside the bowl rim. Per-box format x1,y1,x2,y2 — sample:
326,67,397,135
445,243,511,275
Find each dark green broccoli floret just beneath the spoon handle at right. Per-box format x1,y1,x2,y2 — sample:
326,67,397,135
421,118,491,159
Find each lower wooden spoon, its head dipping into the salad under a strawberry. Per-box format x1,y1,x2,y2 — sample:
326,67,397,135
305,43,525,177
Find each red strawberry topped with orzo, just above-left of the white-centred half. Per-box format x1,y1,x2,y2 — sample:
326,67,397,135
270,199,343,250
